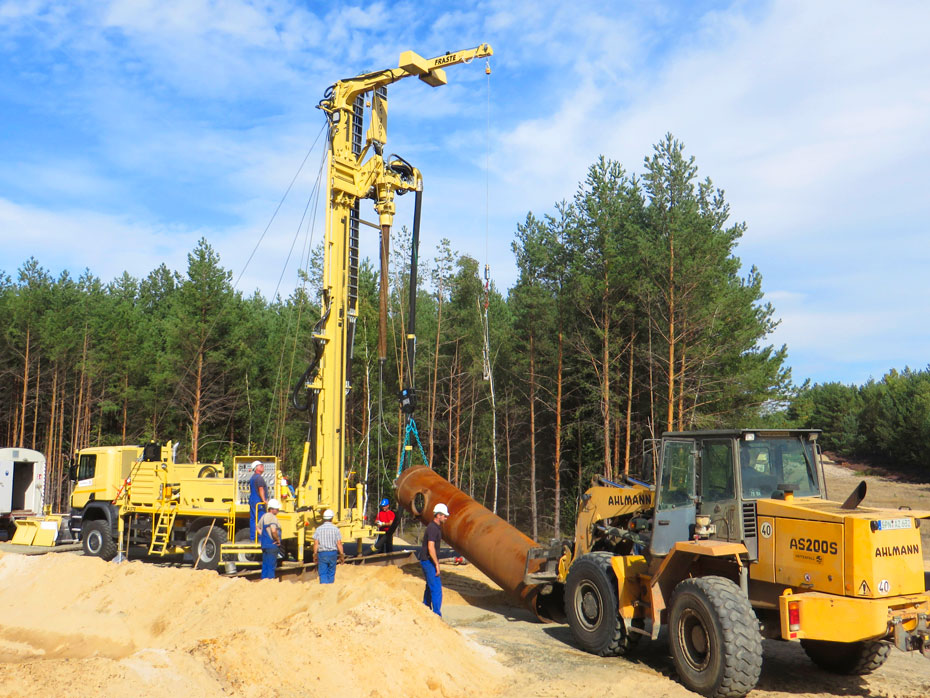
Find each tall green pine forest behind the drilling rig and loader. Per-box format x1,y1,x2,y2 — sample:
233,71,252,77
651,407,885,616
7,135,926,540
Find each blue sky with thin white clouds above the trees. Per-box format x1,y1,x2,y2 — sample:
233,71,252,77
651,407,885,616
0,0,930,383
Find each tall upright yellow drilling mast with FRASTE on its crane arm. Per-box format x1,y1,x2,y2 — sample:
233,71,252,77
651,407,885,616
292,44,493,550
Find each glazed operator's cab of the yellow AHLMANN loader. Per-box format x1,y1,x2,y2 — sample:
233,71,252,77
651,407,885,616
650,429,824,558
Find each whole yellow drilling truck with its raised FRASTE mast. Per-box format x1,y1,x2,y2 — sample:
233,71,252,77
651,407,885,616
45,44,493,569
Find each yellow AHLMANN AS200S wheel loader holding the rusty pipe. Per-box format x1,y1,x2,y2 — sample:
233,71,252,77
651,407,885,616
524,429,930,698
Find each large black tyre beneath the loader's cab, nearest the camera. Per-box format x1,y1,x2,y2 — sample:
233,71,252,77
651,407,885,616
668,576,762,698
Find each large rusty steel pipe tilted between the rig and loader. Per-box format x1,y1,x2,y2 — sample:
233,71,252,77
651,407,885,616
397,465,554,620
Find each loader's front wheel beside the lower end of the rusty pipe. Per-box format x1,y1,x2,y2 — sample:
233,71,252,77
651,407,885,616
565,552,639,657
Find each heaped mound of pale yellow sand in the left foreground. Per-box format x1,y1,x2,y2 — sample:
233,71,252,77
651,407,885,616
0,555,510,698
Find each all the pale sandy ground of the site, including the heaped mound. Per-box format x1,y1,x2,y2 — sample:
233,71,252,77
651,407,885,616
0,454,930,698
